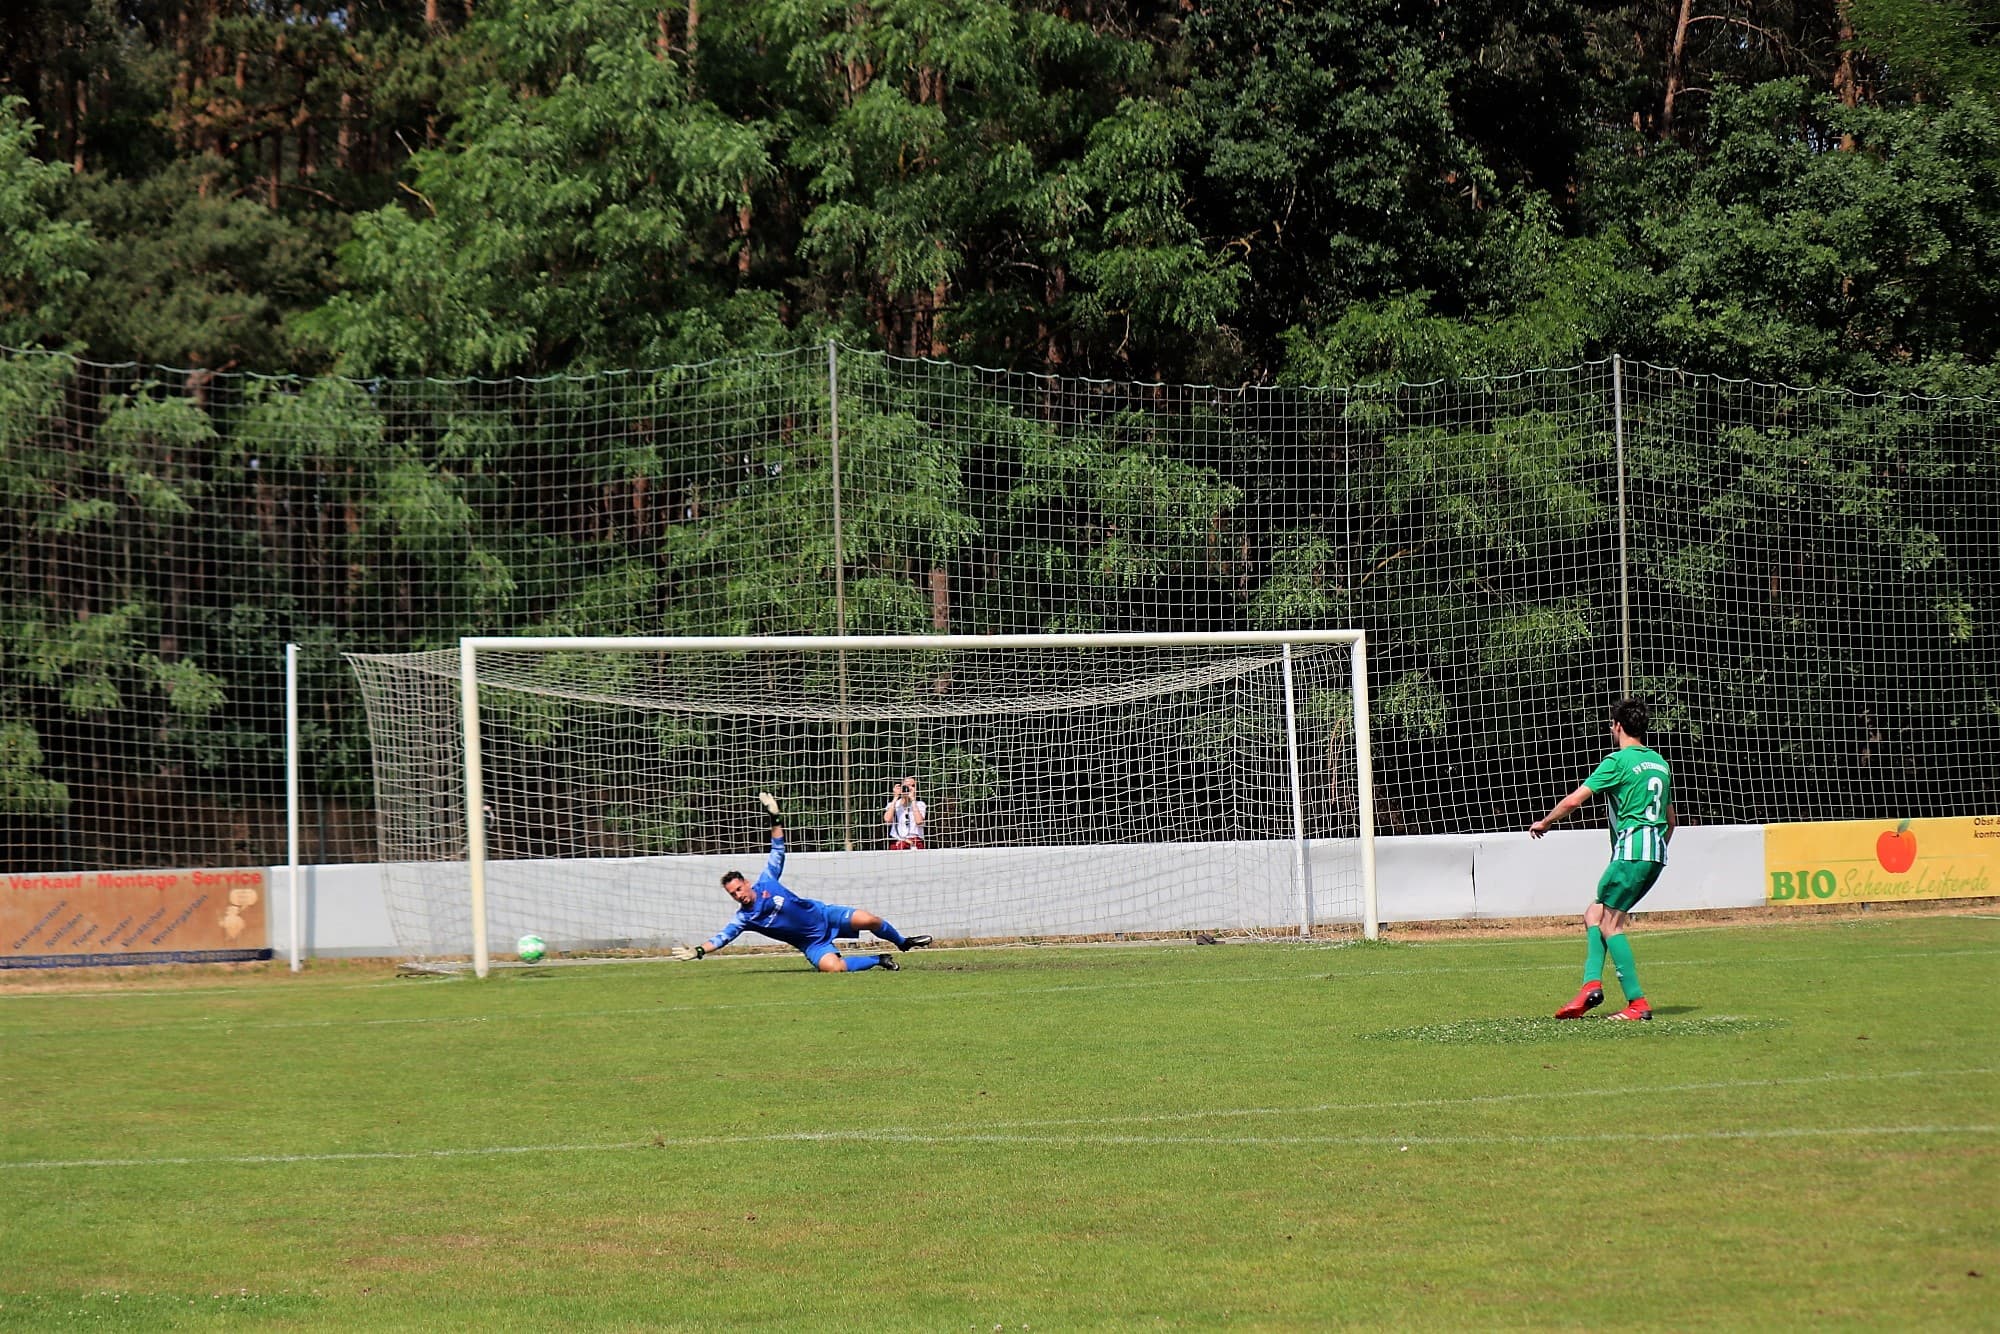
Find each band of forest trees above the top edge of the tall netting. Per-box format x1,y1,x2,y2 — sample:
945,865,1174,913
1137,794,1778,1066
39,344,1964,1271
19,0,2000,388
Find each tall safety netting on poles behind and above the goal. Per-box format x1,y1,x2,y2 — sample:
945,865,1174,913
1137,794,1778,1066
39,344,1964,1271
0,346,2000,888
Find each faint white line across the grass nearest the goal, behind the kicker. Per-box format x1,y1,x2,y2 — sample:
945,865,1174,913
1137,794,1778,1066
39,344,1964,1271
0,948,2000,1040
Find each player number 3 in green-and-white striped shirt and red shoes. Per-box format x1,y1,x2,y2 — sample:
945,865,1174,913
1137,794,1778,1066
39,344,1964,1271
1528,700,1674,1020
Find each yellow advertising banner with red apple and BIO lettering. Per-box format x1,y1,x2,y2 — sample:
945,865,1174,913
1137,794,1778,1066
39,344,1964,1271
1764,816,2000,904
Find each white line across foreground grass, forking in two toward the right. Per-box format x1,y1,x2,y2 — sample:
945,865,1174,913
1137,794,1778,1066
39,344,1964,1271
0,1066,2000,1172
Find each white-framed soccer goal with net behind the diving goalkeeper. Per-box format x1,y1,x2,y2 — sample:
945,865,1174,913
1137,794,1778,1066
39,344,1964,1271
350,630,1376,972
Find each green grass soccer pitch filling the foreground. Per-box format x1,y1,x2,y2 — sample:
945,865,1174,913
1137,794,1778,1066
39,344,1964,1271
0,916,2000,1330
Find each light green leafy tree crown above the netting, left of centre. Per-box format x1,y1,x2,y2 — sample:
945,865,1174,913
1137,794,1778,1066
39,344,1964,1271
302,0,774,372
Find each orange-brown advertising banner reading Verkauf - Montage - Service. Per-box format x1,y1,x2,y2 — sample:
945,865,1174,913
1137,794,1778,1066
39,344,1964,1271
0,868,270,968
